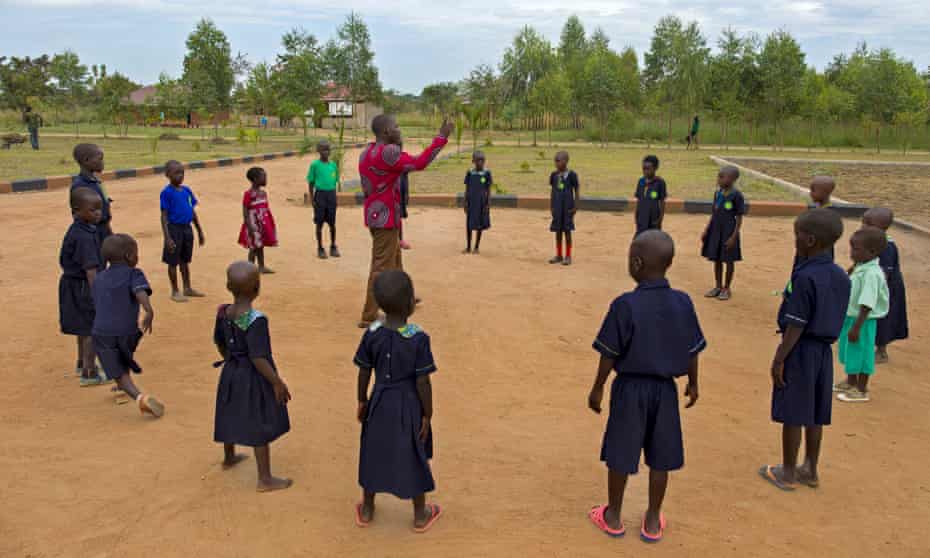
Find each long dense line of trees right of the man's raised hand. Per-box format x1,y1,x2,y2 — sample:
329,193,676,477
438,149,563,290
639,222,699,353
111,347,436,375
416,16,930,150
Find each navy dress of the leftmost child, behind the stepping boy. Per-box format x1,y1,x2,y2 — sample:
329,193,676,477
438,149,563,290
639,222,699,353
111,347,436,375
58,219,103,337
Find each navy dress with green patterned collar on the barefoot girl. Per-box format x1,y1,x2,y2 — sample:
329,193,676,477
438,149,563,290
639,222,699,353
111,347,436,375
213,305,291,447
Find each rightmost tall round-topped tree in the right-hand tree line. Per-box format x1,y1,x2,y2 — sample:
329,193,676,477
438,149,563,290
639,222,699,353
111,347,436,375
759,31,807,148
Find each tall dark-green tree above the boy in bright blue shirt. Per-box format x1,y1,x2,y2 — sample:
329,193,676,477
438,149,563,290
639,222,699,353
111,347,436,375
181,18,237,135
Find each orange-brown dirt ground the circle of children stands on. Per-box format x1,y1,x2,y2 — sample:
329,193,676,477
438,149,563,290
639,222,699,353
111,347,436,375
0,153,930,558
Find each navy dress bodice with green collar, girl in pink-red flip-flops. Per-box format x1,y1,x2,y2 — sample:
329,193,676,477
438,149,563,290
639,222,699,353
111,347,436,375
353,322,436,384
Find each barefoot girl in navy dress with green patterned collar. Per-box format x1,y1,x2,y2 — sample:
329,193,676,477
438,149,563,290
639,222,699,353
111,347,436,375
213,262,292,492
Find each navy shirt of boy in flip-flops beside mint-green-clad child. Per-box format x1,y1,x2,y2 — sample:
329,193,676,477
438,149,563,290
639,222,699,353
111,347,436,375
778,253,851,343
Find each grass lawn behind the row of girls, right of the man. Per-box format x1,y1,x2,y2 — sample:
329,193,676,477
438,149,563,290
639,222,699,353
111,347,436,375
398,146,800,201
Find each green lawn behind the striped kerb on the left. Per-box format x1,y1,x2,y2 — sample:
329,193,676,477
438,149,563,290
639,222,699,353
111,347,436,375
0,136,316,180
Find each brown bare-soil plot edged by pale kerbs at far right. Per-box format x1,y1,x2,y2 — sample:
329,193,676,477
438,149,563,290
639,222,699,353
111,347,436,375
734,159,930,231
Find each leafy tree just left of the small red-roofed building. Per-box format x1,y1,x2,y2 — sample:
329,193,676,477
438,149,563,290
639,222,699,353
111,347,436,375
272,27,325,137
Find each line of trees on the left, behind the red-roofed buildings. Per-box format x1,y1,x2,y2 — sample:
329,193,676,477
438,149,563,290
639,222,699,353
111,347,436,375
0,13,383,139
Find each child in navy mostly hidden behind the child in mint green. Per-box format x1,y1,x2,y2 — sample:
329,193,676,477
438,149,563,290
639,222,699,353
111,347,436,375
862,207,908,363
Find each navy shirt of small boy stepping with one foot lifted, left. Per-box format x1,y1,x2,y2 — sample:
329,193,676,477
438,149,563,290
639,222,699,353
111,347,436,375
91,263,152,337
